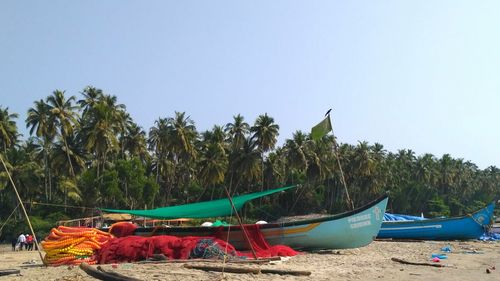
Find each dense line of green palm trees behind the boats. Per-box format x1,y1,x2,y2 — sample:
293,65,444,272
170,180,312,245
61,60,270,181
0,86,500,238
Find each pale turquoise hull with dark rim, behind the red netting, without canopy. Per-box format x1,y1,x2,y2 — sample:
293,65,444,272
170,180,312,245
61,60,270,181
134,196,388,250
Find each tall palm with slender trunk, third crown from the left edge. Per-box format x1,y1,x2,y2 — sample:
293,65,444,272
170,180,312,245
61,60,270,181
47,90,78,178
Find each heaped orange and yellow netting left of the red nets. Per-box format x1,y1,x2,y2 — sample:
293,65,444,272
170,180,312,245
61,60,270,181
41,226,113,266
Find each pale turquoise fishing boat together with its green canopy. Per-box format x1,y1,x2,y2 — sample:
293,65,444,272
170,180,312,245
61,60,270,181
103,187,388,250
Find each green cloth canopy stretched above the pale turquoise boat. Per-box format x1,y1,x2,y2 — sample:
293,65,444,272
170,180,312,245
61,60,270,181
101,185,295,219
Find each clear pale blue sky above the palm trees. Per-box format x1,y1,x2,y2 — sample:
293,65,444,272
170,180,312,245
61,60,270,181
0,0,500,168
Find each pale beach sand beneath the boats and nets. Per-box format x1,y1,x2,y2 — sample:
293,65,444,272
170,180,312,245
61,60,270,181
0,241,500,281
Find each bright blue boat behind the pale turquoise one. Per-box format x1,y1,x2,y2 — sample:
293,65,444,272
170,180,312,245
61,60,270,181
377,202,495,240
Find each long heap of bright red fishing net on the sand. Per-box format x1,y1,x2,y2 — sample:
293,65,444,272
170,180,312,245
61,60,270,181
97,223,298,263
